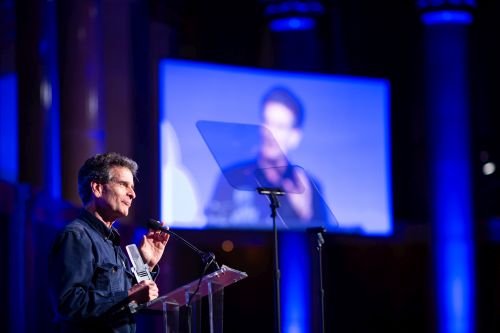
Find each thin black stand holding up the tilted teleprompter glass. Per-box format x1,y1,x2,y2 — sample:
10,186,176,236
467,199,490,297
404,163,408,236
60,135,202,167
257,187,285,333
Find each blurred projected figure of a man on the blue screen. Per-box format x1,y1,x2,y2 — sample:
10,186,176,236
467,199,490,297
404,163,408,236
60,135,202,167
205,87,327,228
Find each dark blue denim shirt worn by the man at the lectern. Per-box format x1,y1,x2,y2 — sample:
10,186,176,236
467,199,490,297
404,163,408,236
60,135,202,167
49,210,153,333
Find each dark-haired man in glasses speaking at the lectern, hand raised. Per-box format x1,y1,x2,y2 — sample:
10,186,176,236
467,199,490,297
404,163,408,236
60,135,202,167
49,153,169,333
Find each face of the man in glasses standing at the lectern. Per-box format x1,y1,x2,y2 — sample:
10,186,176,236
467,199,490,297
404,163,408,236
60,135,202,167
94,167,135,221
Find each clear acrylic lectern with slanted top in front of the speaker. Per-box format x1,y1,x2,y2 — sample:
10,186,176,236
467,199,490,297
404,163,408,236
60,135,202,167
146,265,248,333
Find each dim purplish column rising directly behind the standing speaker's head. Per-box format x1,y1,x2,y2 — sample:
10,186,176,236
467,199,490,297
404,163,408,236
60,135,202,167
58,0,105,205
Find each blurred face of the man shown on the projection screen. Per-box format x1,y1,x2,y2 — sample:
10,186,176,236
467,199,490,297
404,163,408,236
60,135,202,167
262,102,302,159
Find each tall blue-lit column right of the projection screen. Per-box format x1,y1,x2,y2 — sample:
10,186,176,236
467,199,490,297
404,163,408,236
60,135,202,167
418,0,475,333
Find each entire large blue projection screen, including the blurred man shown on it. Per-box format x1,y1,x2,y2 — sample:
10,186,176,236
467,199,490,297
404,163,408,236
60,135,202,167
160,60,392,235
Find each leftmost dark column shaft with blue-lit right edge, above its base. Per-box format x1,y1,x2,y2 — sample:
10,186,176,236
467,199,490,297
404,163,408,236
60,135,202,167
16,0,61,197
